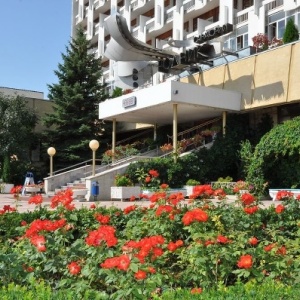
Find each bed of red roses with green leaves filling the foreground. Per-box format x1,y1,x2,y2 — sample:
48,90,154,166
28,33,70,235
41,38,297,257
0,185,300,299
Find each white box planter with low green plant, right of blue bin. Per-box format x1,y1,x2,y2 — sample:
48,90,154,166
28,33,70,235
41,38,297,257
110,174,141,201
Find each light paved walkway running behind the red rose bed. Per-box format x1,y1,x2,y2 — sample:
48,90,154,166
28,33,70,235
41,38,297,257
0,194,278,212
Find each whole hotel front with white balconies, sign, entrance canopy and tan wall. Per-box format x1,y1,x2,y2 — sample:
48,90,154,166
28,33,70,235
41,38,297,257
72,0,300,146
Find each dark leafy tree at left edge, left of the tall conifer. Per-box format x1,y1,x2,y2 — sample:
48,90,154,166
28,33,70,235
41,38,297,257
0,93,38,183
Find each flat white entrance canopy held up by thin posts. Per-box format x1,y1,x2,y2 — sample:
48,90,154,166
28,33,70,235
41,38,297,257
99,81,241,125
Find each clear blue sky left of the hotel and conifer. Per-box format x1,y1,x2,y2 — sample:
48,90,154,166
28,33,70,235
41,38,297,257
0,0,72,99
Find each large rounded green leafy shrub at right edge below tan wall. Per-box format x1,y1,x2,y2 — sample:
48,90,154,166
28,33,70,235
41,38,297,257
246,117,300,193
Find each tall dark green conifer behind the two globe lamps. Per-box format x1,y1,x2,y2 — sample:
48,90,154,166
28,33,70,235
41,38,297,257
43,28,107,167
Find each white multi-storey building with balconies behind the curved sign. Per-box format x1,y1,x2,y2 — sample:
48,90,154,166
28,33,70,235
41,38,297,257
72,0,300,89
